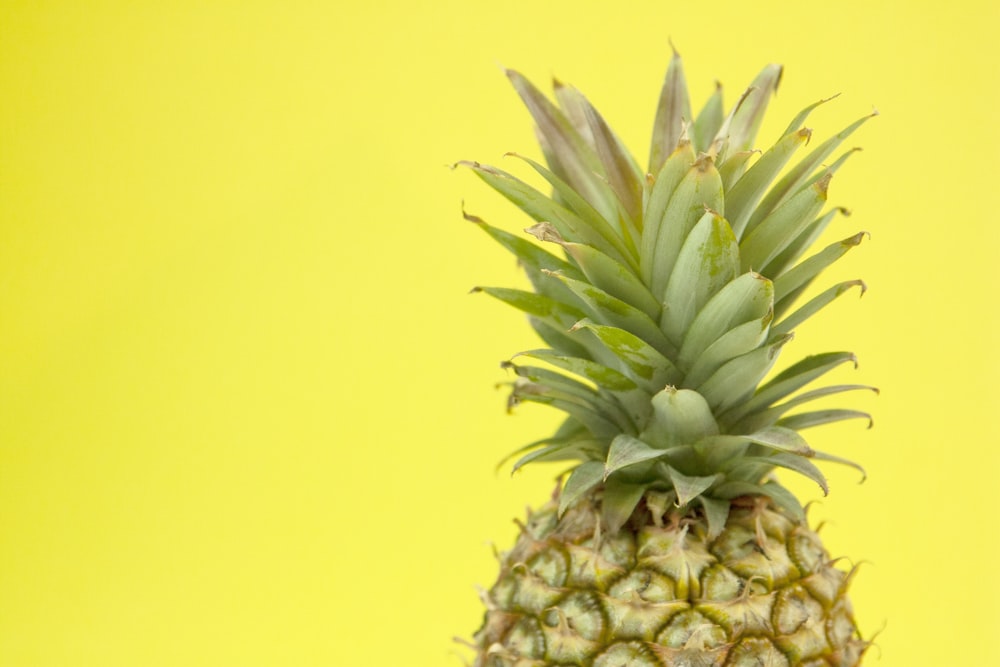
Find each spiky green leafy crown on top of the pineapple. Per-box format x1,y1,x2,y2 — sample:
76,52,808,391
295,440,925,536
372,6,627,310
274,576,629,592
460,53,873,530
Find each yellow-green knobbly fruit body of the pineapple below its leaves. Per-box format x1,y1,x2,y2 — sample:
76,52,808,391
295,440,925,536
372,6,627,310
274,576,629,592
474,490,868,667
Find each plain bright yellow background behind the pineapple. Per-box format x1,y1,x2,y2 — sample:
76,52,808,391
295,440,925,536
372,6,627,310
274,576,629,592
0,0,1000,667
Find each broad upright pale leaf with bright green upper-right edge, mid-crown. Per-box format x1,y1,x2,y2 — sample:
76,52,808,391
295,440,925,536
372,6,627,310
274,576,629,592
660,211,740,346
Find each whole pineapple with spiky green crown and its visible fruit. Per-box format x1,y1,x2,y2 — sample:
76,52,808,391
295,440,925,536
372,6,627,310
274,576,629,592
459,53,874,667
